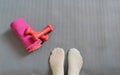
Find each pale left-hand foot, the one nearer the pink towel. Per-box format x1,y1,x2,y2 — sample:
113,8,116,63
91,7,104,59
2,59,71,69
49,48,65,75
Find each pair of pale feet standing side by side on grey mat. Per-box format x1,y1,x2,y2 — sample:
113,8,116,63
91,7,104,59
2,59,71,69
49,48,83,75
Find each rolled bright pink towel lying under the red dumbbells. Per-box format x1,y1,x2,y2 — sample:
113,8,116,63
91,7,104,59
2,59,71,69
10,18,42,52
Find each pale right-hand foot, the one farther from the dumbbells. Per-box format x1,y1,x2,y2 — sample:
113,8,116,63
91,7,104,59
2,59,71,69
68,48,83,75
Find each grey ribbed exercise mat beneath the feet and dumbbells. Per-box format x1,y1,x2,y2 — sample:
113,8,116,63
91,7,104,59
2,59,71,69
0,0,120,75
